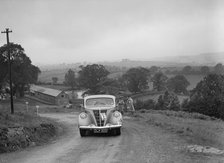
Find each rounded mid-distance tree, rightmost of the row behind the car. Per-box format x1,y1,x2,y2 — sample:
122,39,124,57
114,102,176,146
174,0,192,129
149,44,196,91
167,75,190,93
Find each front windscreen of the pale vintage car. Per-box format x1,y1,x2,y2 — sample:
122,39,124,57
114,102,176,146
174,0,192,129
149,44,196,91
86,98,114,107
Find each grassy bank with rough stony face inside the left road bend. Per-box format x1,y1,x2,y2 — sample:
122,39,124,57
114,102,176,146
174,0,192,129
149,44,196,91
0,99,61,153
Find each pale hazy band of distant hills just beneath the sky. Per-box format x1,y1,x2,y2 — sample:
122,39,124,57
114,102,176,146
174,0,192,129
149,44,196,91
39,52,224,71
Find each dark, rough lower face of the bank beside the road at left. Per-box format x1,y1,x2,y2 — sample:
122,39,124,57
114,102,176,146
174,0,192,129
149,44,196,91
0,123,56,154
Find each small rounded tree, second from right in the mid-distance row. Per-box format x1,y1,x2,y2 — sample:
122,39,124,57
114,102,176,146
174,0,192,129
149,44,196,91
152,72,168,91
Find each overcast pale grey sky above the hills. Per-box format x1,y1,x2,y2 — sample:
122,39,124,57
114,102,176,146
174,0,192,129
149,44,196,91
0,0,224,64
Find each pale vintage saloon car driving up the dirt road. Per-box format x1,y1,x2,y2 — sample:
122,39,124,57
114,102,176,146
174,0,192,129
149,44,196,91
78,95,122,136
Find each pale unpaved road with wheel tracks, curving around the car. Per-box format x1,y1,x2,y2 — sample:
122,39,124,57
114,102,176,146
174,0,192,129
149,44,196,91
0,113,224,163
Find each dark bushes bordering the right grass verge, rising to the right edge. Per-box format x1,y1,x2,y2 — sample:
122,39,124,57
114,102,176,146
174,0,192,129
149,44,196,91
136,74,224,120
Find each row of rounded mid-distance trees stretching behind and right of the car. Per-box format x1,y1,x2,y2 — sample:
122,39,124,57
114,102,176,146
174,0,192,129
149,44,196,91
64,64,190,94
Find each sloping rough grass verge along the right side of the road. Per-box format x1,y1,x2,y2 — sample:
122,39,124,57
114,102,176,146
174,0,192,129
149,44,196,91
135,110,224,149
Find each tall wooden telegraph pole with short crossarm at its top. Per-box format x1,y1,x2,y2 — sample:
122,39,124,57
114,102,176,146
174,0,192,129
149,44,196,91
1,28,14,114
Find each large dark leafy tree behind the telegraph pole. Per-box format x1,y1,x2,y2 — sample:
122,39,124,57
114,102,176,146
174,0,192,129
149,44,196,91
0,43,40,97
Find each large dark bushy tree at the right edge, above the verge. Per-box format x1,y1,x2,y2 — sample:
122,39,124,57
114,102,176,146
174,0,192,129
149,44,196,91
187,74,224,119
